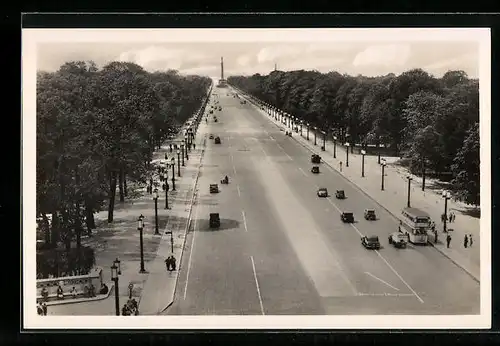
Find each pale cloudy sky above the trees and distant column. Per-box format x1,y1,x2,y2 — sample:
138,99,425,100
37,30,479,78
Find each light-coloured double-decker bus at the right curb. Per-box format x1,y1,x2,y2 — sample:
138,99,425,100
399,207,431,244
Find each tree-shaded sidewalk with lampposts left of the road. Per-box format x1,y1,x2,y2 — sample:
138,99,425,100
48,111,209,316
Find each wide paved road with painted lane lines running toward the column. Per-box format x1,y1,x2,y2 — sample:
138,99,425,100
162,91,479,315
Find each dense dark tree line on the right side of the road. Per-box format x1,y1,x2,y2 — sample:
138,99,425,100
228,69,479,204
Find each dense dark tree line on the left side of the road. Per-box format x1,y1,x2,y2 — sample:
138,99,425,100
36,61,211,256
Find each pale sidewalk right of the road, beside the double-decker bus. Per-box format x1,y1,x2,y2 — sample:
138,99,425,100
240,90,480,282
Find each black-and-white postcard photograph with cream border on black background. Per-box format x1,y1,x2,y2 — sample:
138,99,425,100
22,28,491,330
